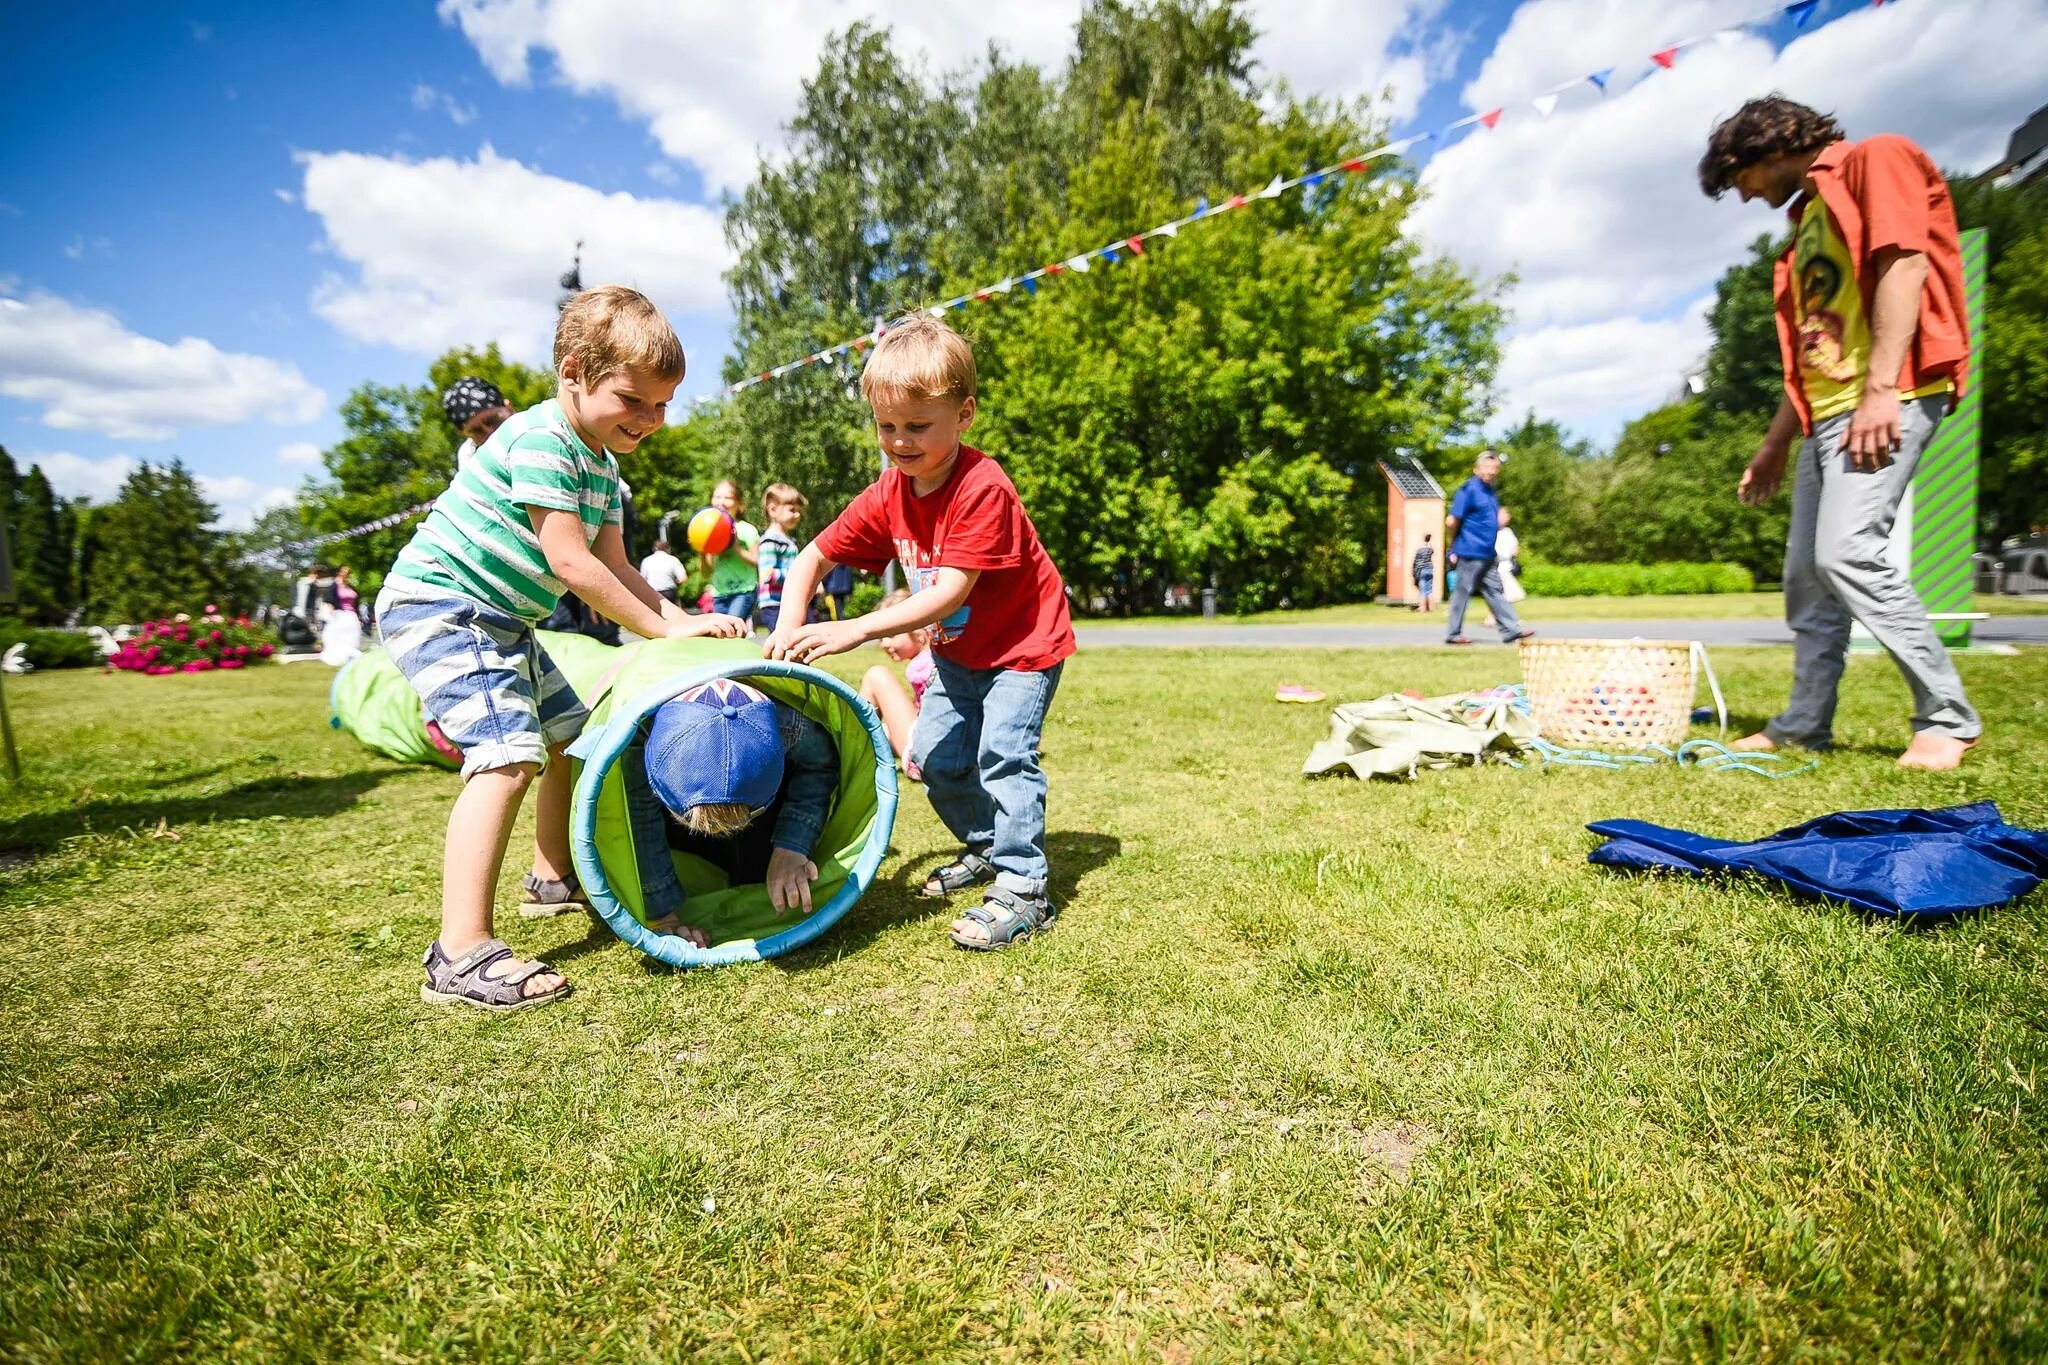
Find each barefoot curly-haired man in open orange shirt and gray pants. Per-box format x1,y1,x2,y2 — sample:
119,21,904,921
1700,94,1982,769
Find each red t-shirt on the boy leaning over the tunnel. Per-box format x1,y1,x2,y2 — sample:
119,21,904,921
817,446,1073,671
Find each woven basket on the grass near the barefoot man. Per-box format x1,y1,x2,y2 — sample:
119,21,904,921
1522,641,1694,751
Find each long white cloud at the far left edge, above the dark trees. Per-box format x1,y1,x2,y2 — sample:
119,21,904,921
0,293,328,440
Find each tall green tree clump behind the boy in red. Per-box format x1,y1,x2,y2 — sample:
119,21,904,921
720,0,1499,610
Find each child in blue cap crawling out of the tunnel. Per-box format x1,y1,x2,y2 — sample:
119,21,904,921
621,677,840,948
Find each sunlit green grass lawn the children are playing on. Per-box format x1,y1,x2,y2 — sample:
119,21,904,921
0,649,2048,1361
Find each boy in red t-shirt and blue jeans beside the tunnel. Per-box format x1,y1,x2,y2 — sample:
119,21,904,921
766,315,1073,950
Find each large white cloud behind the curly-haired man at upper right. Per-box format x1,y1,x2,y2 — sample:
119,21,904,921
1411,0,2048,435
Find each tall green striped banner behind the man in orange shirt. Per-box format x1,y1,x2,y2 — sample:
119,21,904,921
1913,227,1987,649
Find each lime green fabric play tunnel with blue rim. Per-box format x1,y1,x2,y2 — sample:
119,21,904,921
330,632,897,966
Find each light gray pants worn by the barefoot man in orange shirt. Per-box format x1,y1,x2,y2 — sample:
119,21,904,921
1763,393,1985,749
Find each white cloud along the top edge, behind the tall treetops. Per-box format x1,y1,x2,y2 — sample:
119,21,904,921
438,0,1452,190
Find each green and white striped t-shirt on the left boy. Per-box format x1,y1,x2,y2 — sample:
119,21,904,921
385,399,625,620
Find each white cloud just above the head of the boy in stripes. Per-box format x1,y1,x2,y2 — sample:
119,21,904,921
299,147,731,360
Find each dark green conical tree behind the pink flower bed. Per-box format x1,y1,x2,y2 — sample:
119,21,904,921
86,460,231,624
